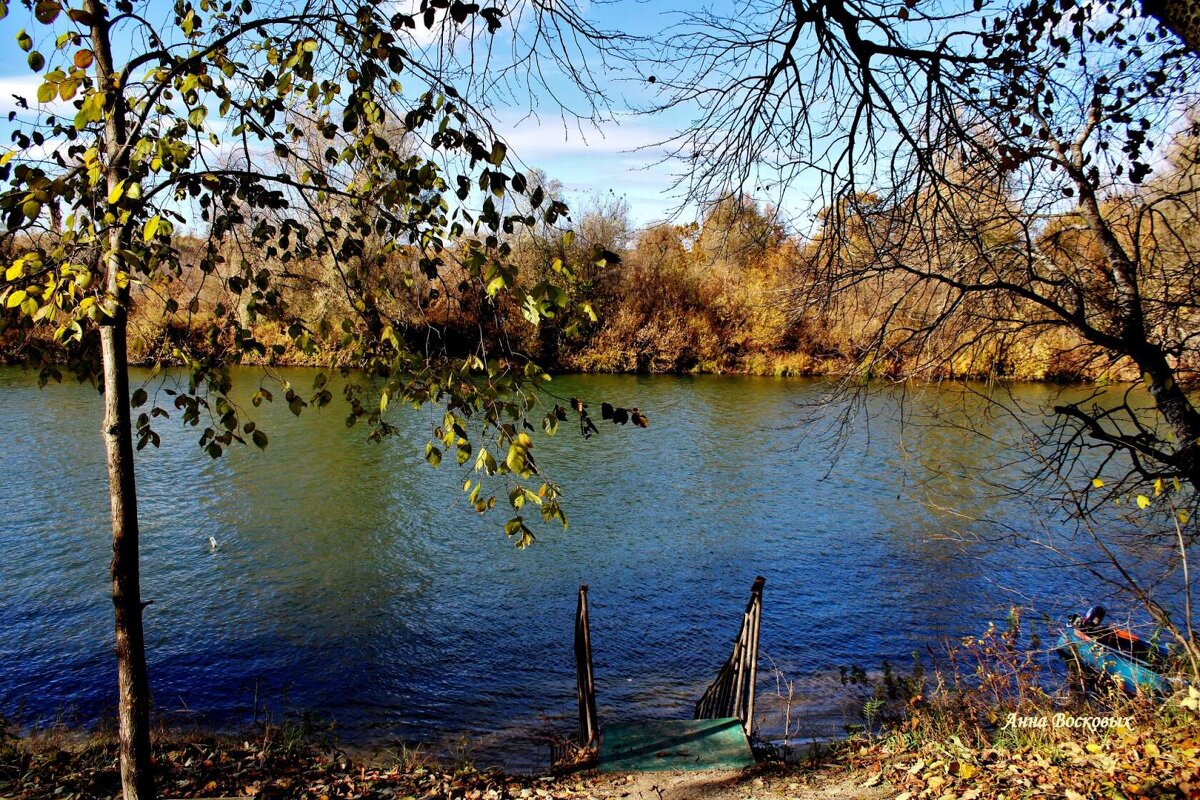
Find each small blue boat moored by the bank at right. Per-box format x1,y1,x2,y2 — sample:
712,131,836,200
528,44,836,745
1056,606,1174,696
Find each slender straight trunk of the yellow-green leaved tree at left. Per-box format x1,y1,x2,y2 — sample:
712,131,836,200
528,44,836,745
83,0,155,800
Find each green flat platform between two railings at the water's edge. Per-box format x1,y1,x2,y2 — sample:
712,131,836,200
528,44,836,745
599,717,754,772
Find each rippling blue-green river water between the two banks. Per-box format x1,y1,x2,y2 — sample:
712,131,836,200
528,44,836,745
0,369,1180,763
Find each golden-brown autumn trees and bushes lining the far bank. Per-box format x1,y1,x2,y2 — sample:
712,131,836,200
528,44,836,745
18,128,1200,380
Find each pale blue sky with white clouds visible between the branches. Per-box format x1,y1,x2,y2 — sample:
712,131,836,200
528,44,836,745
0,0,1190,241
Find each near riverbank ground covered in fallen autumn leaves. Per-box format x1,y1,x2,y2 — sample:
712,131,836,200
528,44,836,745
0,698,1200,800
